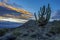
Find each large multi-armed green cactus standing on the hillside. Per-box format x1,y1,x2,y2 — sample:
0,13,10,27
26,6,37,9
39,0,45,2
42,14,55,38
34,4,51,26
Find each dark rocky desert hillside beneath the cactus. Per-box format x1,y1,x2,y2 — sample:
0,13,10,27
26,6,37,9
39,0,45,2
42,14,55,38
0,20,60,40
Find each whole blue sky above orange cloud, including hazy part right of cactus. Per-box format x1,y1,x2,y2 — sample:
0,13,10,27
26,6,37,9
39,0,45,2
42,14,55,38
0,0,60,18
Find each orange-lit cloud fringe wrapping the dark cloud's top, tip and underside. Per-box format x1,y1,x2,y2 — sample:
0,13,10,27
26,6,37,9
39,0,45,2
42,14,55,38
0,2,32,18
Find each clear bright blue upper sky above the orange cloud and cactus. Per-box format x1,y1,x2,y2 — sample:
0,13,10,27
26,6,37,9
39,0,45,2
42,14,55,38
5,0,60,13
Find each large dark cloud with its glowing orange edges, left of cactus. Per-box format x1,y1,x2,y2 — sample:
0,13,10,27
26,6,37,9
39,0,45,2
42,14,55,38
0,2,32,19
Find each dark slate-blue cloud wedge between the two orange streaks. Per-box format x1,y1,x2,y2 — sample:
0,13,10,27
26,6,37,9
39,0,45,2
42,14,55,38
0,6,20,16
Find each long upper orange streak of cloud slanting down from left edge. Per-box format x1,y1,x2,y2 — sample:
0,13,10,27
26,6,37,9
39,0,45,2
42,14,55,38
0,2,32,15
